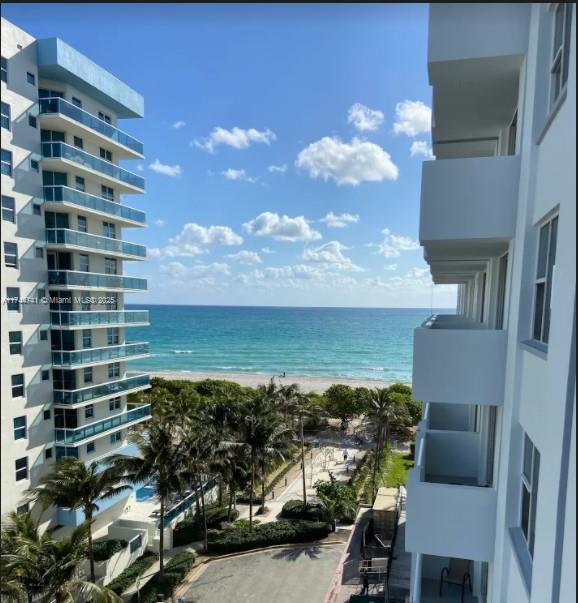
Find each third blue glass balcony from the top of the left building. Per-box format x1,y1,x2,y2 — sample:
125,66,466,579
44,186,146,226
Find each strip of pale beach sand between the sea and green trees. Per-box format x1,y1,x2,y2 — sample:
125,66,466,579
150,371,400,394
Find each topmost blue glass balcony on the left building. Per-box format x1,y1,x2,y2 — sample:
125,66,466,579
39,98,144,159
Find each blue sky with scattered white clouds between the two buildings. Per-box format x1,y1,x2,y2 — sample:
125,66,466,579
2,3,456,308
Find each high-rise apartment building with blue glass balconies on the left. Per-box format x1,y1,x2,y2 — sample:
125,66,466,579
0,19,150,531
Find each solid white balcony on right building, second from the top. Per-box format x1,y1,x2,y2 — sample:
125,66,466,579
420,156,520,261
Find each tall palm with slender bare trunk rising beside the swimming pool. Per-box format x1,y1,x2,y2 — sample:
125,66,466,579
106,416,183,579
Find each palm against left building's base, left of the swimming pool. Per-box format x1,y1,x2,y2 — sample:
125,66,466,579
30,457,131,582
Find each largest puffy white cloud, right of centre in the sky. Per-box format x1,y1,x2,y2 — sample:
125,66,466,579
295,136,399,186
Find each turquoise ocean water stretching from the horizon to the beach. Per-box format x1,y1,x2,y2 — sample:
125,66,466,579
127,306,453,381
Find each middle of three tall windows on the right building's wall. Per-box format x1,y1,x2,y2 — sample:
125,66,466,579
533,216,558,343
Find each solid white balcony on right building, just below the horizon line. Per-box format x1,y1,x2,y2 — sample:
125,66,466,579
413,316,507,406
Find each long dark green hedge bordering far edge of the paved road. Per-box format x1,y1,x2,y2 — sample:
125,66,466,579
208,519,331,555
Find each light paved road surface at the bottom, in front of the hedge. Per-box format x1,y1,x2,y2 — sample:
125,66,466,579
181,544,344,603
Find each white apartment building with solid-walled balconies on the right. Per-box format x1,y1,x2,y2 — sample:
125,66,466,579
406,3,576,603
